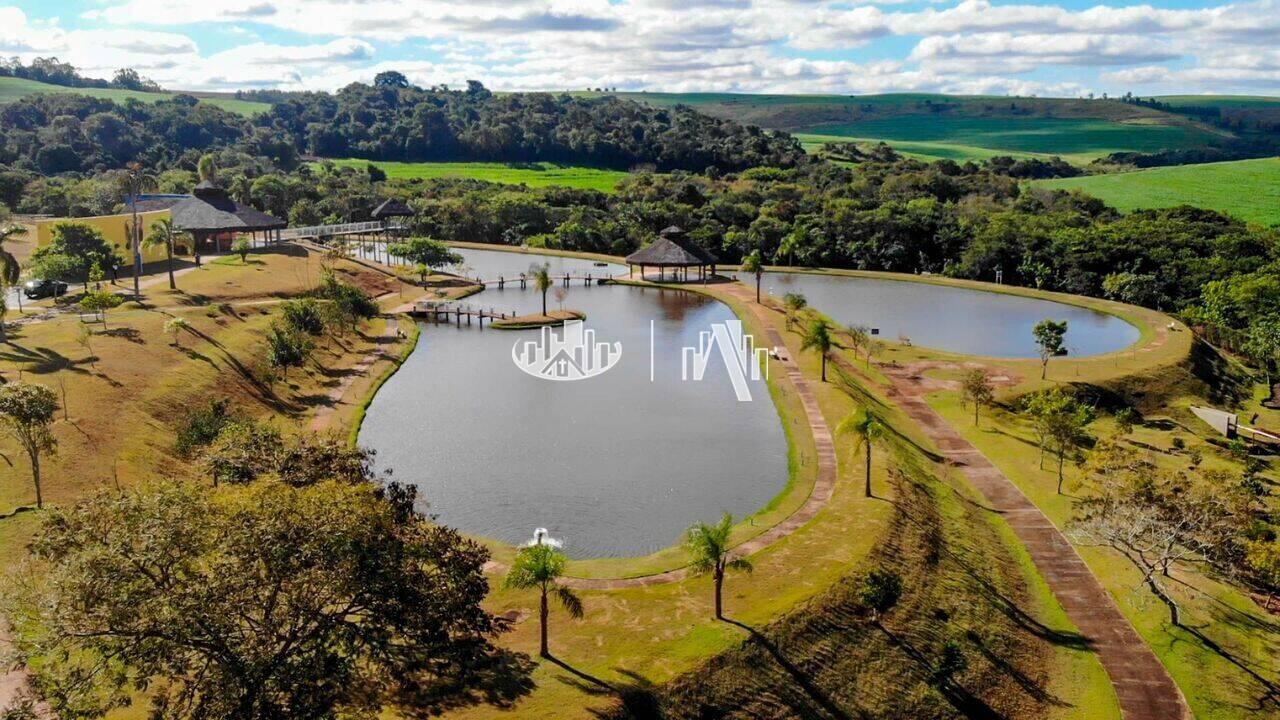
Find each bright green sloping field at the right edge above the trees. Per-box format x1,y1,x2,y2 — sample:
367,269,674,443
1036,158,1280,225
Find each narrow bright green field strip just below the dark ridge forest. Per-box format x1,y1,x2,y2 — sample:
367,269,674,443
325,159,627,192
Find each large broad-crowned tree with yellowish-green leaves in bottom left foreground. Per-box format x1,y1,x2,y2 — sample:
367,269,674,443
10,482,506,720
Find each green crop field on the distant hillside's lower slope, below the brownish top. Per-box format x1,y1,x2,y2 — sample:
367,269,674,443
788,115,1212,161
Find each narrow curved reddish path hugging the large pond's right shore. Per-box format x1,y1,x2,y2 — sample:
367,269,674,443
562,283,836,589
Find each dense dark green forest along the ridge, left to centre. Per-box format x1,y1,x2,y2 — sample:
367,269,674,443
0,73,805,176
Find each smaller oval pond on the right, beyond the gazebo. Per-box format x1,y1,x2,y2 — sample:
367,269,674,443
757,273,1139,357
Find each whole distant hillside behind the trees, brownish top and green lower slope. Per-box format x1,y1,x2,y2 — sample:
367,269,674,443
606,92,1229,163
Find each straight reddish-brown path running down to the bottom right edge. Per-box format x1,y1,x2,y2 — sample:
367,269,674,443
865,356,1192,720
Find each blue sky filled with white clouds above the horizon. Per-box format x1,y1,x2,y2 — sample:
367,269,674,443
0,0,1280,96
